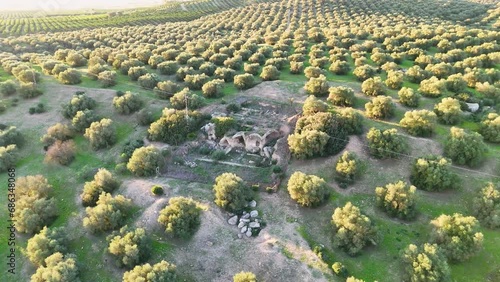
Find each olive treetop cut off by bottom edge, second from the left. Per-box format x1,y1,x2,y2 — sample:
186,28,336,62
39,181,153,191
123,260,177,282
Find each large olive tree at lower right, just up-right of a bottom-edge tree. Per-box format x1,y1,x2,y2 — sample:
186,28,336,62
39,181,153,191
431,213,483,262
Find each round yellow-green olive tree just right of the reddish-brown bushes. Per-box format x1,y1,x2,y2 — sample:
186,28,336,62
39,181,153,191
83,118,116,150
